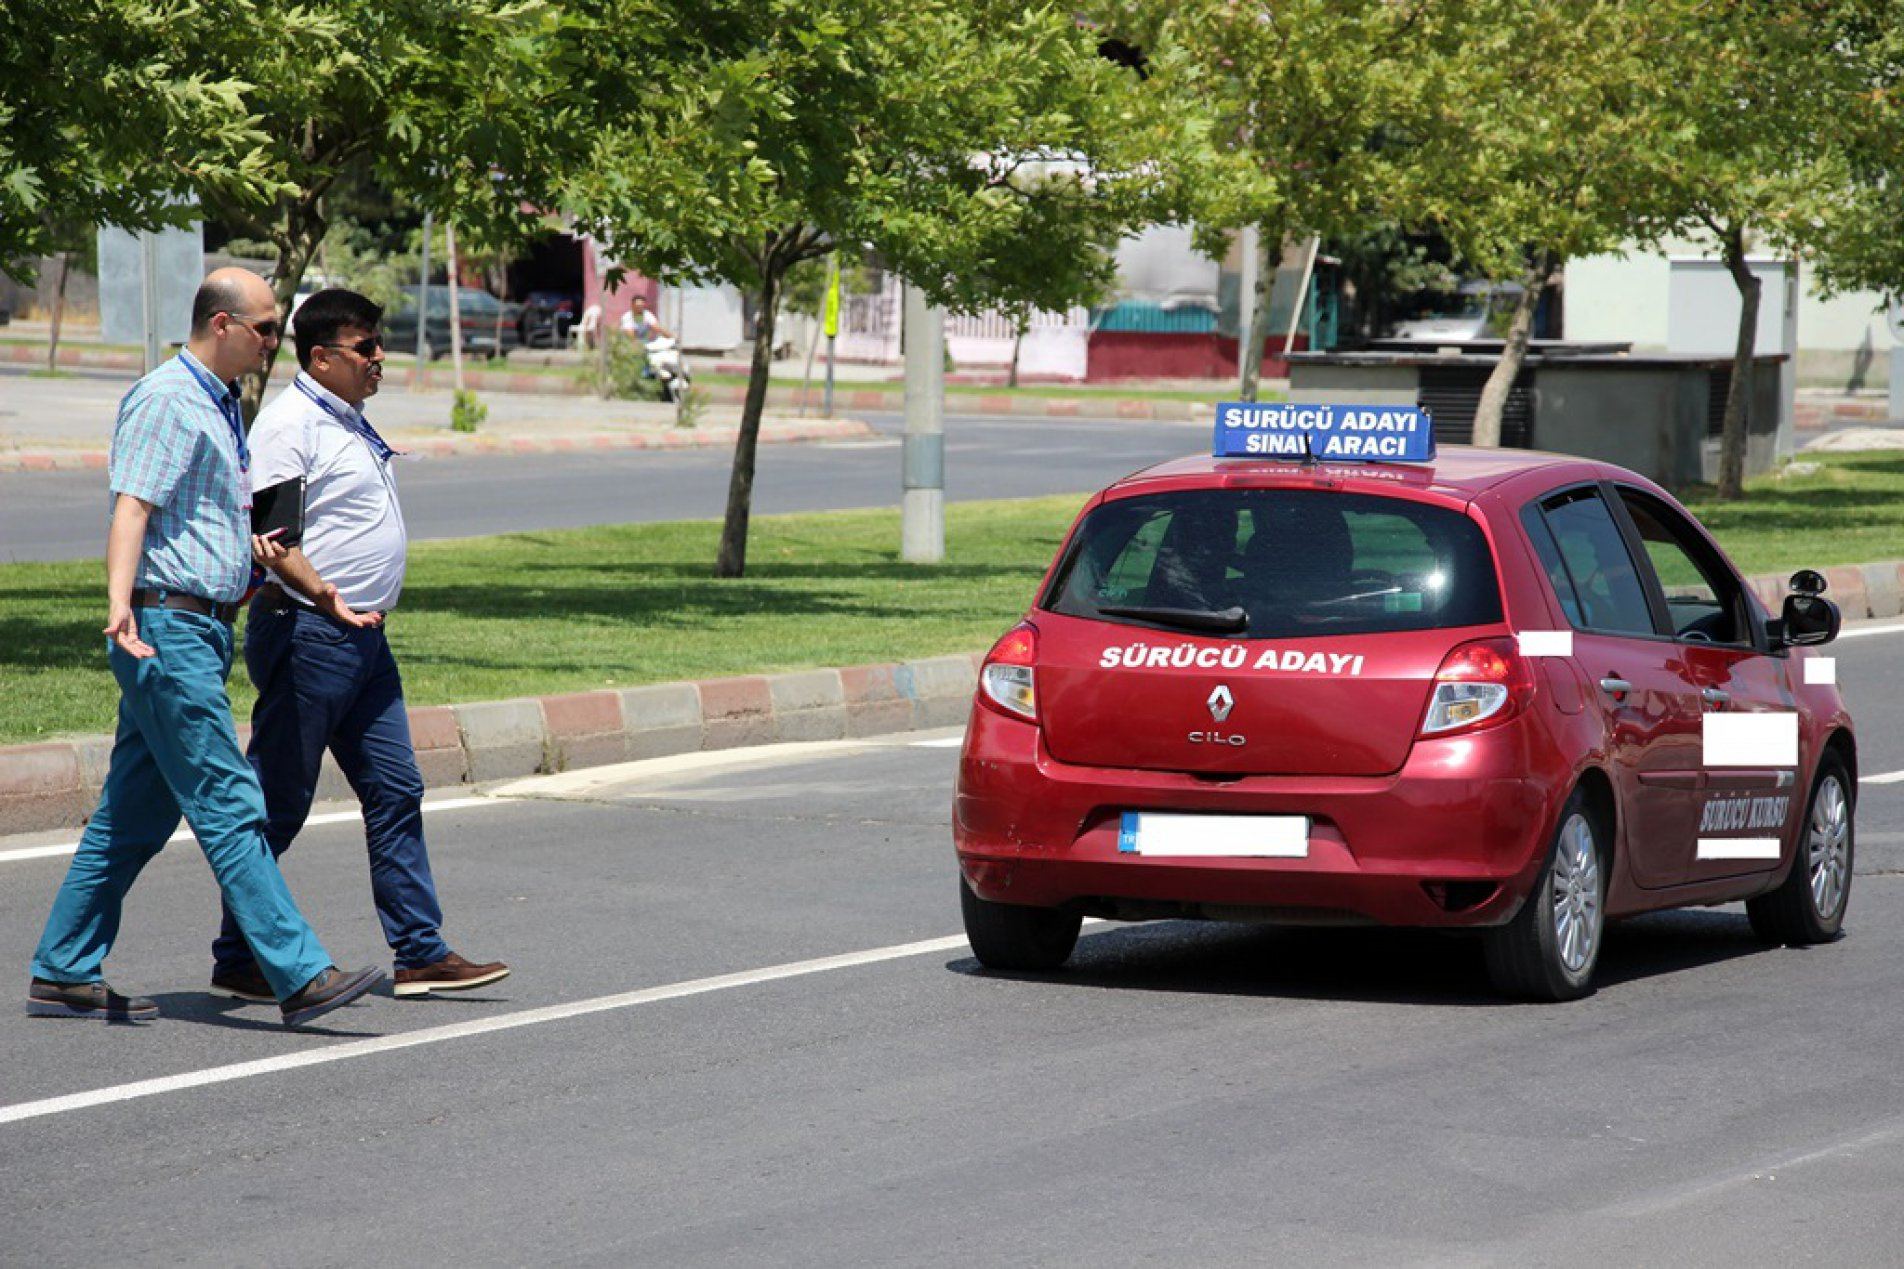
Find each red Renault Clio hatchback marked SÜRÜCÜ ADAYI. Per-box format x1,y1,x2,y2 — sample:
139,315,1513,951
954,448,1856,1000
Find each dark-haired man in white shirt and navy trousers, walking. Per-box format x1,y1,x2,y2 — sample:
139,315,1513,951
211,290,508,1002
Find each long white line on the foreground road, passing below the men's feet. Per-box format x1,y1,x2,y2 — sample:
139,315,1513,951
0,920,1104,1124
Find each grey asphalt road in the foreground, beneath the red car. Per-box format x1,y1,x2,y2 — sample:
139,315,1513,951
0,633,1904,1267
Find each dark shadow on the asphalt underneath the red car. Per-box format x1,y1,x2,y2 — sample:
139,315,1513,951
946,911,1775,1008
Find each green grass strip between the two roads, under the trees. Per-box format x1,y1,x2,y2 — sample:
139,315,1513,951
11,452,1904,743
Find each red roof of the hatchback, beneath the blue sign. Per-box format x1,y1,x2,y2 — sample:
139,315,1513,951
1104,446,1609,501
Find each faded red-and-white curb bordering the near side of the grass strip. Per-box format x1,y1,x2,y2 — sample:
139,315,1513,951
0,560,1904,836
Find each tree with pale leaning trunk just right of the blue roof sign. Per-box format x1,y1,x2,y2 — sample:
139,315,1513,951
1401,0,1689,446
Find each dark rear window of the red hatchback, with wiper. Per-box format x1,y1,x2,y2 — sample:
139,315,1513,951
1043,490,1500,638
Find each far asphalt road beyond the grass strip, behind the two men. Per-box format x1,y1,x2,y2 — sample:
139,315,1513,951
0,415,1209,562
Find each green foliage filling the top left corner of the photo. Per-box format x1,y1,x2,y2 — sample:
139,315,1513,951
0,0,274,266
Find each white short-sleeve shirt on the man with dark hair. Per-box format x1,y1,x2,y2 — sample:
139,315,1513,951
251,372,409,612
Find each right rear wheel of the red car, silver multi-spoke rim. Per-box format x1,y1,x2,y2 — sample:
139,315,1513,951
1485,789,1607,1000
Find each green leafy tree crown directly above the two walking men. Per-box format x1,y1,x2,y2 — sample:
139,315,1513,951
124,0,672,410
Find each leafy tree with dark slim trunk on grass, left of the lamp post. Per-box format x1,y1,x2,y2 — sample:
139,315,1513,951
565,0,1198,577
